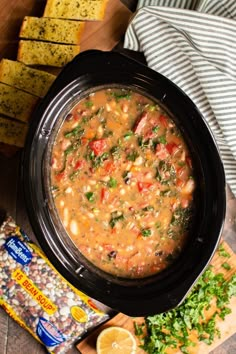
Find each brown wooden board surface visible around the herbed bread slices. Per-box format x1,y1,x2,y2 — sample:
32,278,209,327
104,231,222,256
0,0,132,60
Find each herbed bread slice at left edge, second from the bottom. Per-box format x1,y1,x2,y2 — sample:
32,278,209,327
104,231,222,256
0,83,39,122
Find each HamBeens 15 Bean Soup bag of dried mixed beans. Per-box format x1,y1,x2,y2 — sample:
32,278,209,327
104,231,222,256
0,217,108,353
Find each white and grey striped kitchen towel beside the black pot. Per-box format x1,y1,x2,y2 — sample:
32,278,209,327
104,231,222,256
124,0,236,195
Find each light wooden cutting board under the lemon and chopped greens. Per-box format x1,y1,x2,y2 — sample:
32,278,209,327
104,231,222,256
77,242,236,354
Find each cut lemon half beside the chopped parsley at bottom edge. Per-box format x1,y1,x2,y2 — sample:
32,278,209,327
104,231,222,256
97,326,137,354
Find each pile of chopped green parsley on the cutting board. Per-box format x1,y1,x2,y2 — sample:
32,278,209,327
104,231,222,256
135,267,236,354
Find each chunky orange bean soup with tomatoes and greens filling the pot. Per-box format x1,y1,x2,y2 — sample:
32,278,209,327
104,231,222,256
51,89,195,278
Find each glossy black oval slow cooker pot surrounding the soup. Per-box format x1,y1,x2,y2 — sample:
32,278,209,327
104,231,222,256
22,51,226,316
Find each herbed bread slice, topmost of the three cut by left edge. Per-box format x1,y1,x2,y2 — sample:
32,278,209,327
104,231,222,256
0,59,56,97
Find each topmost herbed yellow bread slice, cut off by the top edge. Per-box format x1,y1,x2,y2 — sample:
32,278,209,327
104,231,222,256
43,0,108,21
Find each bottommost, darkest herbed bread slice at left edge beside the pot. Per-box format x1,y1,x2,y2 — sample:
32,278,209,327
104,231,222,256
0,115,28,148
